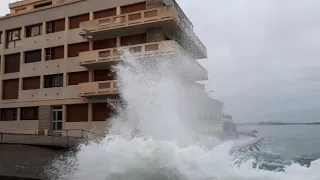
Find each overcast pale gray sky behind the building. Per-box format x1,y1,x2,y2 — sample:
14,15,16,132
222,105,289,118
0,0,320,122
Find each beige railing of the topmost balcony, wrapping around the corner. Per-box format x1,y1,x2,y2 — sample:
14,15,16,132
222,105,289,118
80,6,207,56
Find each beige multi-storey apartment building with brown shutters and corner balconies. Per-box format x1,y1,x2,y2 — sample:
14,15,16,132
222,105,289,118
0,0,208,136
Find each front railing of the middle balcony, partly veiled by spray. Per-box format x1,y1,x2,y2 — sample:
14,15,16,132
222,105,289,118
79,41,182,67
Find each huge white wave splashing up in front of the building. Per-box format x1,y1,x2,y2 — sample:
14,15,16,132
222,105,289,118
50,52,320,180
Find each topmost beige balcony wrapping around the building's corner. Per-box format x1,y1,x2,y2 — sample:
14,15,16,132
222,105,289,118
80,6,207,59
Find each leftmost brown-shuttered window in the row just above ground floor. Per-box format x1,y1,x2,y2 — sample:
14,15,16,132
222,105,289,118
2,79,19,100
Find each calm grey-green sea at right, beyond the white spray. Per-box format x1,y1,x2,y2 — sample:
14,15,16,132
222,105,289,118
238,125,320,165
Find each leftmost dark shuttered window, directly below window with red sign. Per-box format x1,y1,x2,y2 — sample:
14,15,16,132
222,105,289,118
4,53,20,74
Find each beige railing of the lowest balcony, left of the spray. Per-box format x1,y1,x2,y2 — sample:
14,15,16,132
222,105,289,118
79,81,119,97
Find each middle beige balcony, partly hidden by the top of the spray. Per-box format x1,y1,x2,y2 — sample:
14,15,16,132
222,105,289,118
79,40,208,81
